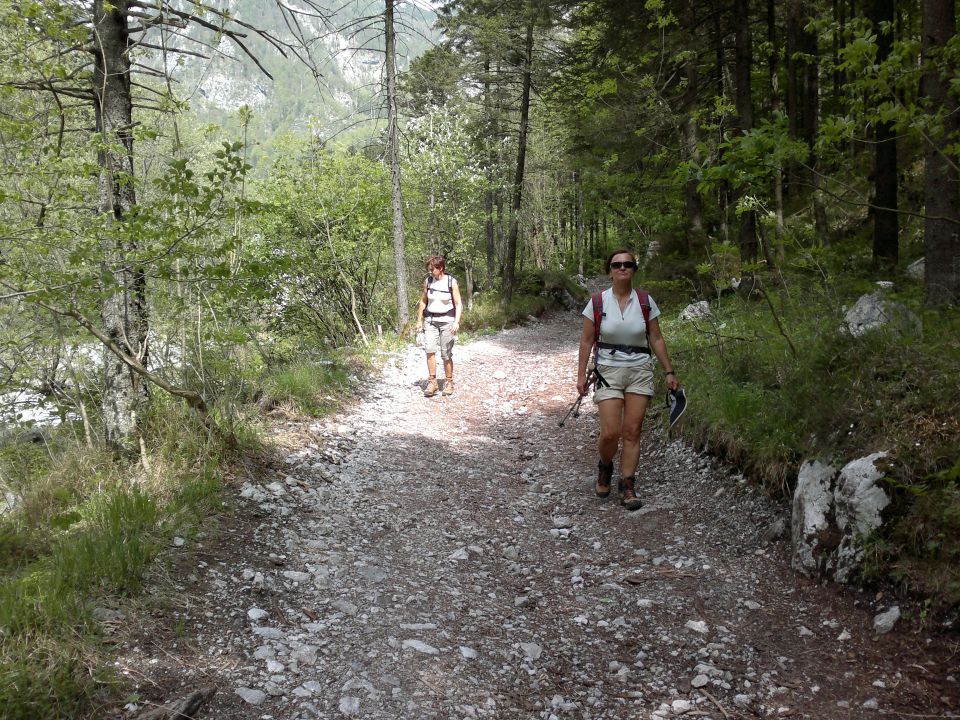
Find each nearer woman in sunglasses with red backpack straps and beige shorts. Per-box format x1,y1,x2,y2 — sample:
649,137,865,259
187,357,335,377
577,249,680,510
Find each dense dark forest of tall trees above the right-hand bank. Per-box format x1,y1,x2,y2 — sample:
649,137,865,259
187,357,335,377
430,0,960,304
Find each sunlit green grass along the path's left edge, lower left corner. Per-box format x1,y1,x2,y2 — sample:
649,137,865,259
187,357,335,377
0,396,255,718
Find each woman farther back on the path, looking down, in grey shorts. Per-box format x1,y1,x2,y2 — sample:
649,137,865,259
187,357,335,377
416,255,463,397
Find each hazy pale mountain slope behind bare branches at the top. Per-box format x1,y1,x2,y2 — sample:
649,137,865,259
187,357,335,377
152,0,439,155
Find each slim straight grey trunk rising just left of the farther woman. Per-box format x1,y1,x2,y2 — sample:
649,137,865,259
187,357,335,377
383,0,410,332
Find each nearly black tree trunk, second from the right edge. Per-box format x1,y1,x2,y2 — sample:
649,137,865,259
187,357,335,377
873,0,900,268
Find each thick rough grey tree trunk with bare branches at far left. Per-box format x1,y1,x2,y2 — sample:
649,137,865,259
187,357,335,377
91,0,149,457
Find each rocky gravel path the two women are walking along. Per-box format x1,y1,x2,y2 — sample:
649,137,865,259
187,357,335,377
111,306,960,720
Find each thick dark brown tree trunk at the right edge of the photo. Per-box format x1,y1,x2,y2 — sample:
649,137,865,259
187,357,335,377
920,0,960,306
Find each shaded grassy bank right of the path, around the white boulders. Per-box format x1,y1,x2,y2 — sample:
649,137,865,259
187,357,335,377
663,262,960,606
